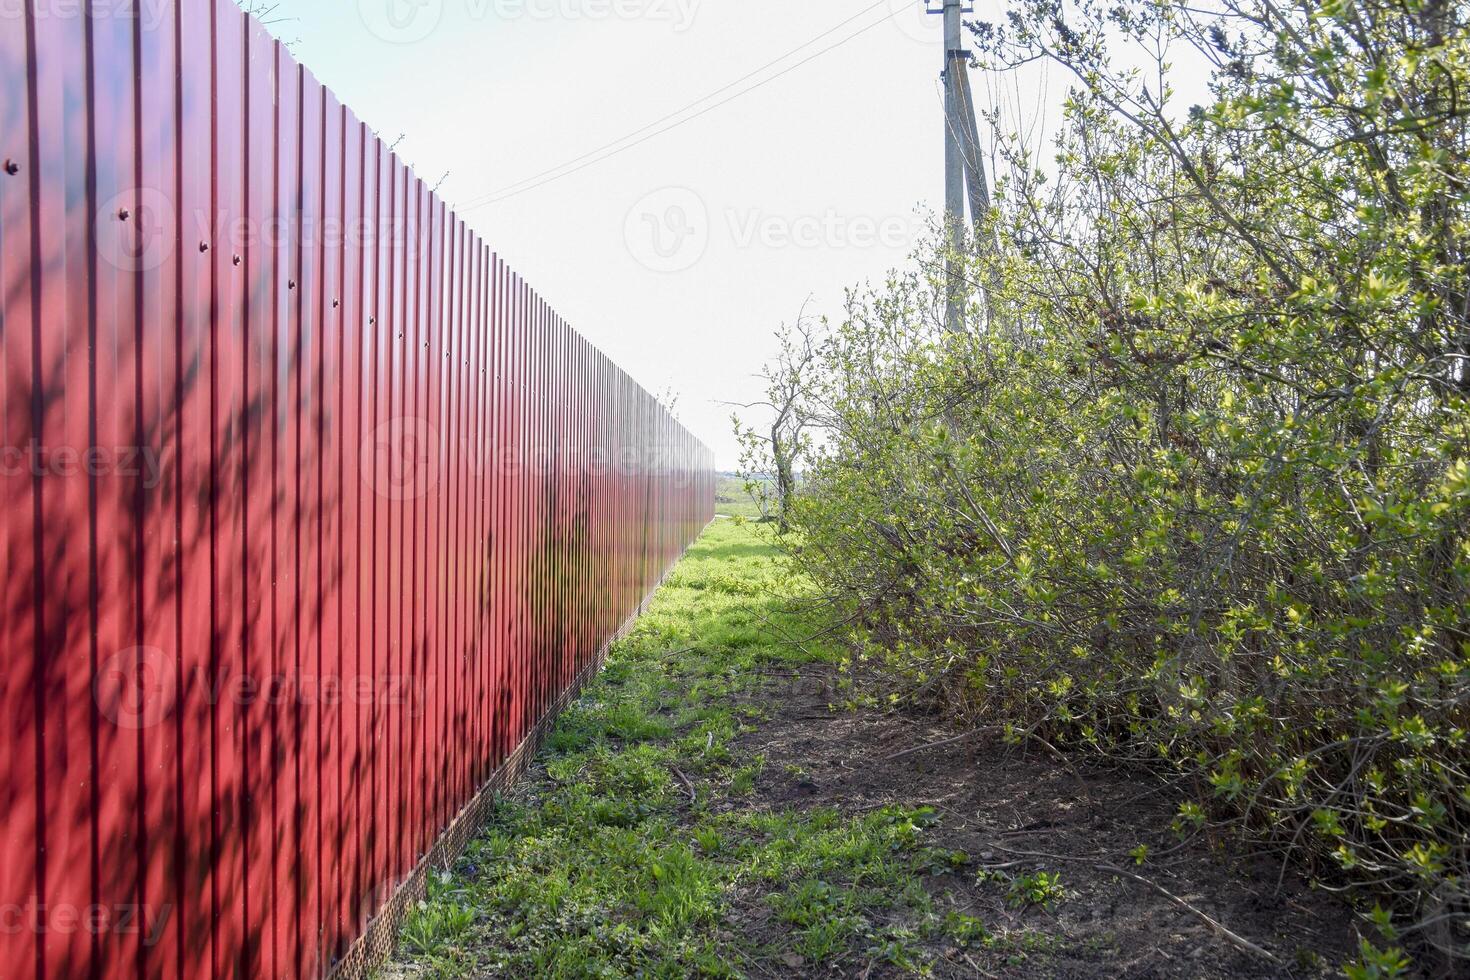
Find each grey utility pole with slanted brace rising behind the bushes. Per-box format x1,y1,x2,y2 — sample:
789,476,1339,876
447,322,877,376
925,0,991,334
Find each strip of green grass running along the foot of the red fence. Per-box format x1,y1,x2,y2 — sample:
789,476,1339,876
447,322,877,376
391,520,1017,977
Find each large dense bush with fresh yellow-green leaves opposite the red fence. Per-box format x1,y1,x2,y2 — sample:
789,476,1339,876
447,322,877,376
753,0,1470,955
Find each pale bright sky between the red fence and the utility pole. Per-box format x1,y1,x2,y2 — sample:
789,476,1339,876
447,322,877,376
249,0,983,469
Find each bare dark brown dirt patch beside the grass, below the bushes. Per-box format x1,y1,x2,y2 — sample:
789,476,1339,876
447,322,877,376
732,666,1357,979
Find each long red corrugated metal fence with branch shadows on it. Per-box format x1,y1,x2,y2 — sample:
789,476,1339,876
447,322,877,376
0,0,713,980
